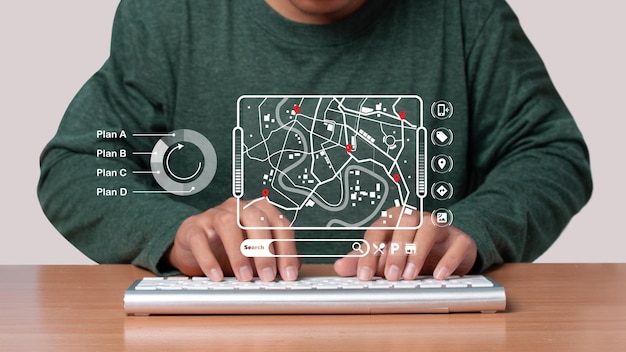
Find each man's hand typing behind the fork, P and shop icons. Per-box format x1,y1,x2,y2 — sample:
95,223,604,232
335,208,478,281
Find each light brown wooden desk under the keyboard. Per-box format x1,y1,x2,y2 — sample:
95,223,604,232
0,264,626,352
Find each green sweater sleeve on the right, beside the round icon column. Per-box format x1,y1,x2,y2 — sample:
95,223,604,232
451,1,592,271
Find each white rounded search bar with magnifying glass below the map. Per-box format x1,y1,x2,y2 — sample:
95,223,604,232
239,238,370,258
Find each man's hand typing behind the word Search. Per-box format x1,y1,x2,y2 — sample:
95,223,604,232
167,198,300,281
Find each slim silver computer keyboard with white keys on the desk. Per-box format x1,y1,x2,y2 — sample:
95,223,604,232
124,275,506,315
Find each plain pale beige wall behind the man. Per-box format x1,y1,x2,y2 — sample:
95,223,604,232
0,0,626,264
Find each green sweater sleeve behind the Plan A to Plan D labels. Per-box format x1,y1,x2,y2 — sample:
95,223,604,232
38,1,194,273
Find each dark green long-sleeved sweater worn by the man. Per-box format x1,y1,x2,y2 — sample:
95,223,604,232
38,0,592,273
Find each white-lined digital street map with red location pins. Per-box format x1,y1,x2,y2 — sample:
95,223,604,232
233,95,426,229
